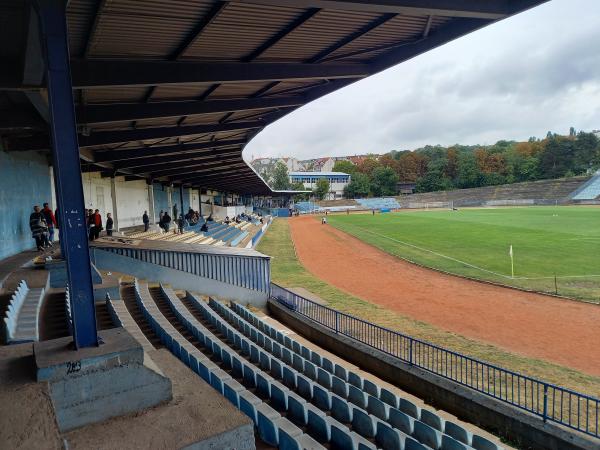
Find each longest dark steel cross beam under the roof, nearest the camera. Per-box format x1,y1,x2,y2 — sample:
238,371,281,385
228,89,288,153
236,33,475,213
71,59,371,89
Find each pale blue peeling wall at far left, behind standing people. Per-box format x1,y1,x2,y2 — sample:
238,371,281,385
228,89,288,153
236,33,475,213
0,150,52,258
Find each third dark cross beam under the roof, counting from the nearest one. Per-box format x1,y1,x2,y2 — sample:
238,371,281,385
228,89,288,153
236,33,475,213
79,120,267,147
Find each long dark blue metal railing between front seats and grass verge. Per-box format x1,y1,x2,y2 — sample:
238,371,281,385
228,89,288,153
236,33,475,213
271,283,600,438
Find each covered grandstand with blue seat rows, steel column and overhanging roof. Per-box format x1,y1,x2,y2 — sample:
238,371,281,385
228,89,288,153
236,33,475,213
0,0,597,450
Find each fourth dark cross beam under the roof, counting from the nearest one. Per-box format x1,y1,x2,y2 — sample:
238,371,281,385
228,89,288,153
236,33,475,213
94,139,246,162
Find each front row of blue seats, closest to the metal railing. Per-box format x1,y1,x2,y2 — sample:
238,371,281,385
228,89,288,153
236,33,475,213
225,302,501,450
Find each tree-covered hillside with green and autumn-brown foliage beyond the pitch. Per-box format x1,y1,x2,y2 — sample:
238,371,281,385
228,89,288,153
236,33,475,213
334,128,600,197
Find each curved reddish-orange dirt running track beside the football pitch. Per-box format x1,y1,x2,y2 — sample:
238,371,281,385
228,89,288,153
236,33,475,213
290,217,600,375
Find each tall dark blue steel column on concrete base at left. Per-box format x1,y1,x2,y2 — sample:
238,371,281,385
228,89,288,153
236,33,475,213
37,0,98,348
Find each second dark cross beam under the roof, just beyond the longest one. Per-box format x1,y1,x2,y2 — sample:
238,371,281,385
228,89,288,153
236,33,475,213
77,96,304,124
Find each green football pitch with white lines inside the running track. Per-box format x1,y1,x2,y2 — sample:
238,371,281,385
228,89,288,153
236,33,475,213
328,206,600,303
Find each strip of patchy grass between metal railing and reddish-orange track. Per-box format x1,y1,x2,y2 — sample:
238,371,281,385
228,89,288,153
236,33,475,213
258,219,600,397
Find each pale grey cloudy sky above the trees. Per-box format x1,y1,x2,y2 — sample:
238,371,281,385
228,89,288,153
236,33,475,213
244,0,600,159
